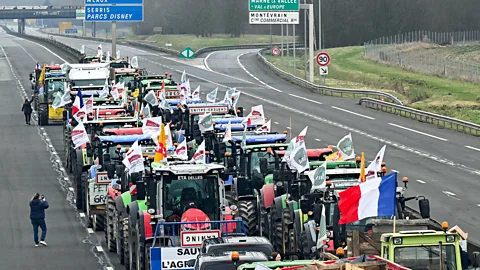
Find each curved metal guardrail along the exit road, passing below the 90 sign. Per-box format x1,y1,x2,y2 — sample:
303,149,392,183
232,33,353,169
257,49,403,105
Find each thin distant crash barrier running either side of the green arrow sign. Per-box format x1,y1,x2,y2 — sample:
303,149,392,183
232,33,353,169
37,31,303,56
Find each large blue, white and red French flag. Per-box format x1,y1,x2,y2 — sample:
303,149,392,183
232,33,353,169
338,173,397,224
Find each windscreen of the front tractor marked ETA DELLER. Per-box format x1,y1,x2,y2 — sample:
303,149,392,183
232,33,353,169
163,175,220,221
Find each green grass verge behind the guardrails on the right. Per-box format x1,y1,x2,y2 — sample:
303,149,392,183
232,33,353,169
266,47,480,124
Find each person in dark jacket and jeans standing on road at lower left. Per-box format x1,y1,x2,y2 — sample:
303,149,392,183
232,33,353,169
30,193,48,247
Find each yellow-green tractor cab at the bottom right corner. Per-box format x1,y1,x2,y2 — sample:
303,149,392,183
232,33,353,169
380,226,464,270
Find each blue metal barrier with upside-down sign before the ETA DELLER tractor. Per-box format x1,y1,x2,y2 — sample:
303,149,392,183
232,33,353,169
153,220,247,247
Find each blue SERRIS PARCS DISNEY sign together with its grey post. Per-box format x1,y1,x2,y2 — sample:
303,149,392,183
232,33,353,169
85,0,144,60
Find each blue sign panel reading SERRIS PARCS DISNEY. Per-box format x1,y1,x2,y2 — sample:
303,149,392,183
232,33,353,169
85,6,143,22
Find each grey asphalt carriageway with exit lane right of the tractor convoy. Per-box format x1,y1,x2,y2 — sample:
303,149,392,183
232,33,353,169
10,29,480,247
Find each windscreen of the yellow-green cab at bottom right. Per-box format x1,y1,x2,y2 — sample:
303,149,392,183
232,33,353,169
394,244,458,270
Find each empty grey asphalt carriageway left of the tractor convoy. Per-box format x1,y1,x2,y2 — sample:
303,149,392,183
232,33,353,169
0,33,120,270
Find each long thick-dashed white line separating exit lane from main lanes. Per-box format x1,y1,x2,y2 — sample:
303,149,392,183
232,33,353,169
55,37,480,178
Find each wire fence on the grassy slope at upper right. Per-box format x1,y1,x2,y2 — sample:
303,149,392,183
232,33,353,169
364,31,480,82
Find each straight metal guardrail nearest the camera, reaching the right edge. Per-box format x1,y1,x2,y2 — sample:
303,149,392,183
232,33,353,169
358,98,480,136
